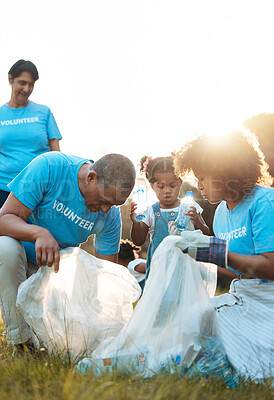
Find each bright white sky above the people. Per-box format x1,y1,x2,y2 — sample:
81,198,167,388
0,0,274,163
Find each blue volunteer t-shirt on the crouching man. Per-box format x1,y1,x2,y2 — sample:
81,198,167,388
9,152,121,264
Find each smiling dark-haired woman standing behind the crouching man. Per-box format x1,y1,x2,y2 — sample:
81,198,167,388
0,60,62,207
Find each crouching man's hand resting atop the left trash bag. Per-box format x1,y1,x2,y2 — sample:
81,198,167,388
35,229,60,272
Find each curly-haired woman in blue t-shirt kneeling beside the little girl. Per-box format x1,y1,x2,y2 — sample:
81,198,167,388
174,131,274,379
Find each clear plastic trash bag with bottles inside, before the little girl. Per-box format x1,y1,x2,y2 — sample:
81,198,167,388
76,236,237,384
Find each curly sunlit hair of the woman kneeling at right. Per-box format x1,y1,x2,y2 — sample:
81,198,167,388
173,131,272,196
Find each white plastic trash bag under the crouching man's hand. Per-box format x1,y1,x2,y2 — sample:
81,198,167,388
17,248,141,360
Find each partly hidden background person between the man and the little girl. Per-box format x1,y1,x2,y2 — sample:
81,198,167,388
118,239,146,290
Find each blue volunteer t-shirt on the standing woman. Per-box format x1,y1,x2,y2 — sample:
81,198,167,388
0,101,62,191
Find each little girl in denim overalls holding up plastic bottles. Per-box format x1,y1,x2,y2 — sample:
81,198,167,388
130,156,209,279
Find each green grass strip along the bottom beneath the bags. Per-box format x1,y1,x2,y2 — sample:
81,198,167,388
0,323,274,400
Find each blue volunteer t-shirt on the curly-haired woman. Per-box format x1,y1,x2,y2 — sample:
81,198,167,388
213,186,274,273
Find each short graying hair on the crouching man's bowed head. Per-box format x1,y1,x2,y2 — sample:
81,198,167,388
91,153,136,196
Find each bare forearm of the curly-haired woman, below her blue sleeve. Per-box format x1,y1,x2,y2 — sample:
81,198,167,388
228,252,274,280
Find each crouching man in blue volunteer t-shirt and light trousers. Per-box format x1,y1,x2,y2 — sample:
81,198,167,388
0,152,136,351
